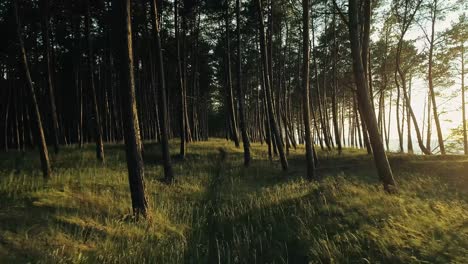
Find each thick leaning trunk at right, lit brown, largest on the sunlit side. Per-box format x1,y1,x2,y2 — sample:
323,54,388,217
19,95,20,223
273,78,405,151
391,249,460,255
348,0,396,192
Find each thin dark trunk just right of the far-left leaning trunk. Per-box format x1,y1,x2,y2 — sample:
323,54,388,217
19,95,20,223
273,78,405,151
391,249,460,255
42,0,59,153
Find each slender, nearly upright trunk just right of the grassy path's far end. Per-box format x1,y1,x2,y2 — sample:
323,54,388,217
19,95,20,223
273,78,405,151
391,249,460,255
236,0,250,167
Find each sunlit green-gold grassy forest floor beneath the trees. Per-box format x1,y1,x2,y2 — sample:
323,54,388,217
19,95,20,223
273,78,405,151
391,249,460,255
0,139,468,264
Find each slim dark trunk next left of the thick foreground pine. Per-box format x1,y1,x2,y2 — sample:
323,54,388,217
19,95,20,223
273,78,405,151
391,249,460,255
85,0,104,162
